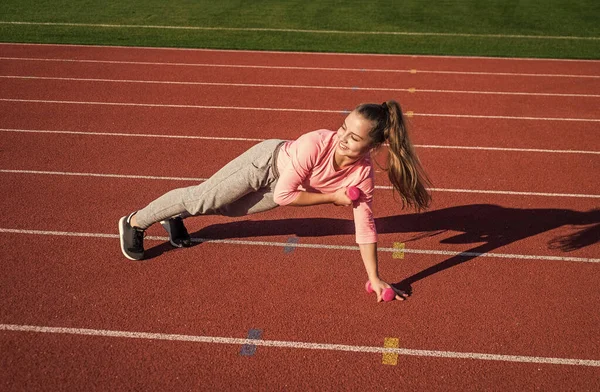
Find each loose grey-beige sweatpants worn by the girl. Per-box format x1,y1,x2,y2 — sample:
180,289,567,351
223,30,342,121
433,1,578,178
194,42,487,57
136,139,284,229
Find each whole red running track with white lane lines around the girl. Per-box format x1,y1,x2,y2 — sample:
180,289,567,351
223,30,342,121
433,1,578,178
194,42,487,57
0,44,600,390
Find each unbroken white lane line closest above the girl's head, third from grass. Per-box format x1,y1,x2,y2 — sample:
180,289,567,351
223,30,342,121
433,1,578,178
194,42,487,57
0,75,600,98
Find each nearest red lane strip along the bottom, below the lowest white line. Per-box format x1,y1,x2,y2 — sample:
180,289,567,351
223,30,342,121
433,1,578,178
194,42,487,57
0,333,597,391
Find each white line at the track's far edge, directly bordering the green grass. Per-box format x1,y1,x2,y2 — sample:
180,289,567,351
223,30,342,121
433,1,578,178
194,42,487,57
0,42,599,63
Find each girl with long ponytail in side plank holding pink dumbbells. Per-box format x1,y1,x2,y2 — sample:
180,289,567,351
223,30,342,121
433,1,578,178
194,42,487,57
119,101,431,302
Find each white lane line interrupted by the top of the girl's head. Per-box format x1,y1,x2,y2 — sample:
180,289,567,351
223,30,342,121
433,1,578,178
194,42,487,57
0,98,600,122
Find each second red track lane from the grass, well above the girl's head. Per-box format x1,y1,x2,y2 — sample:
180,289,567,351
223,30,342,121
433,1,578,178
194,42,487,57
0,59,600,95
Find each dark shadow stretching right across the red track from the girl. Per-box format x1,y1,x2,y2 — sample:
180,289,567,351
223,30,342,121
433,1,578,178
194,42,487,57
149,204,600,294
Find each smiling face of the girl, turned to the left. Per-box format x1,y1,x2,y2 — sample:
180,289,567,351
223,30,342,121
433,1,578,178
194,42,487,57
336,111,373,159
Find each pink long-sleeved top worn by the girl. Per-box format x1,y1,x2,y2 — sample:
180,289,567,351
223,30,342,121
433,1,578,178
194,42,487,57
274,129,377,244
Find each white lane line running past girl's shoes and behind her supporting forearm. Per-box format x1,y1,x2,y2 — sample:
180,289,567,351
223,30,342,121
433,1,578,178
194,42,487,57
0,228,600,263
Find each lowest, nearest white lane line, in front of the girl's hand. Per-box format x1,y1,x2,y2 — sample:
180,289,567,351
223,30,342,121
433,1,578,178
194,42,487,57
0,324,600,367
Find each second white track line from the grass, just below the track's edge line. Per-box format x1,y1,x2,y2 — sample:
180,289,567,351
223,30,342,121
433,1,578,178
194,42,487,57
0,56,600,79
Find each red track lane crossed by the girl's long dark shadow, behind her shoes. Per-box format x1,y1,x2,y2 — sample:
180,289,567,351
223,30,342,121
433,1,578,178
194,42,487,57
0,173,599,263
